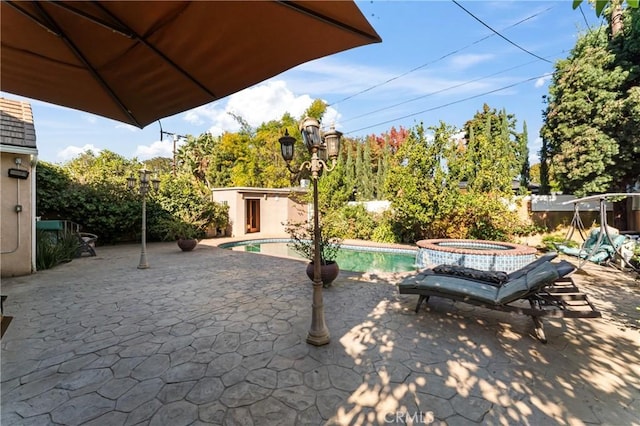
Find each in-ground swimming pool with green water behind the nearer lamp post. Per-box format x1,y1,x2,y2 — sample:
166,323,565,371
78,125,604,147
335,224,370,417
220,238,417,272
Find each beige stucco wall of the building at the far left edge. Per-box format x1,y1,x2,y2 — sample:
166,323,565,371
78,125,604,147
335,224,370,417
0,152,35,277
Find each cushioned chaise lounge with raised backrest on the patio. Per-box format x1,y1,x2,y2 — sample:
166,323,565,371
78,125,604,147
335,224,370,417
398,253,600,343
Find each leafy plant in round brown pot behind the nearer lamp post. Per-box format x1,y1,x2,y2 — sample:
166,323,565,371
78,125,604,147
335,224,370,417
285,221,342,287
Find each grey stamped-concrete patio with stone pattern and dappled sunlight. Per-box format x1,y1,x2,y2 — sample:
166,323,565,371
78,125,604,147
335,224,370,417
0,239,640,426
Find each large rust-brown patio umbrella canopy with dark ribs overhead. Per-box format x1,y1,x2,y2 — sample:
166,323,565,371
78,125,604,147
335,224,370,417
0,0,381,127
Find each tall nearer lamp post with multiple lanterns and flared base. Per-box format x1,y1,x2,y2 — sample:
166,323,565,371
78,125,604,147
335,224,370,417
279,117,342,346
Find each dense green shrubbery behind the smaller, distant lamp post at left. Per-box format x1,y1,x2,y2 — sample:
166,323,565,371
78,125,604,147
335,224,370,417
36,151,228,244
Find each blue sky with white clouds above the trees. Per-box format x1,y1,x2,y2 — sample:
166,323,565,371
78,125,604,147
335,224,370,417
2,1,599,163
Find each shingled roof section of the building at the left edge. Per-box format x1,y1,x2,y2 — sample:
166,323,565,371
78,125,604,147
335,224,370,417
0,98,36,148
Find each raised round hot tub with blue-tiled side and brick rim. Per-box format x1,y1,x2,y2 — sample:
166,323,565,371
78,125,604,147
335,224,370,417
416,239,537,272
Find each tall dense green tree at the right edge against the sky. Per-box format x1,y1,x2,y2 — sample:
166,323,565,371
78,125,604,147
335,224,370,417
541,9,640,196
